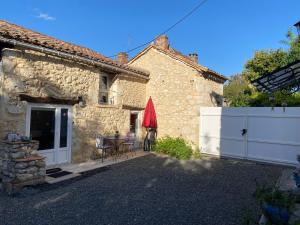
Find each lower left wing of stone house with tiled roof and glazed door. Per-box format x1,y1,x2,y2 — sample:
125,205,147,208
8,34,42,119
0,21,149,165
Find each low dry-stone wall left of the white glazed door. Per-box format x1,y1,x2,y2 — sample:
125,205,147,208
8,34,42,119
0,141,46,193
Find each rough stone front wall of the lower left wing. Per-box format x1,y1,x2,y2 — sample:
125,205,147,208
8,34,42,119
0,49,146,162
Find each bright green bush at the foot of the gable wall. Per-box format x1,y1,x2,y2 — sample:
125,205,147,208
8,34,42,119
154,137,193,159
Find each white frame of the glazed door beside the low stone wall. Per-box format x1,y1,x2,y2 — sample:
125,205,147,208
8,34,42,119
25,103,73,164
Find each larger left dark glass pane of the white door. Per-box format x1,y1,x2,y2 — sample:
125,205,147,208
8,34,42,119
30,109,55,150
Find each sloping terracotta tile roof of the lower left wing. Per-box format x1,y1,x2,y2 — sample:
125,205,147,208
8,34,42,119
0,20,148,75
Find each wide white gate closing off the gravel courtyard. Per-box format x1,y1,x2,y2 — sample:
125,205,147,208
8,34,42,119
199,107,300,164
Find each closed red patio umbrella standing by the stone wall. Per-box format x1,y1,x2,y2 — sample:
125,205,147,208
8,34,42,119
142,97,157,151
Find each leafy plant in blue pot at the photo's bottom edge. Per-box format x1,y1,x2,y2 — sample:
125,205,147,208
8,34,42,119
255,185,295,225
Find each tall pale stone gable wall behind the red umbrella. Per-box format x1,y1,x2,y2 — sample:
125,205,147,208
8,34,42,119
131,48,223,147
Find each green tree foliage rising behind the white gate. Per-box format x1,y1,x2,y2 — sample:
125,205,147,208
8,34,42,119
224,30,300,107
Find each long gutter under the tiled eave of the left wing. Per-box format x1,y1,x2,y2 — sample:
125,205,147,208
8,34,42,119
0,36,149,80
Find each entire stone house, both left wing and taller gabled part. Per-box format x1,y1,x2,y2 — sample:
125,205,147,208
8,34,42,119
0,21,226,165
